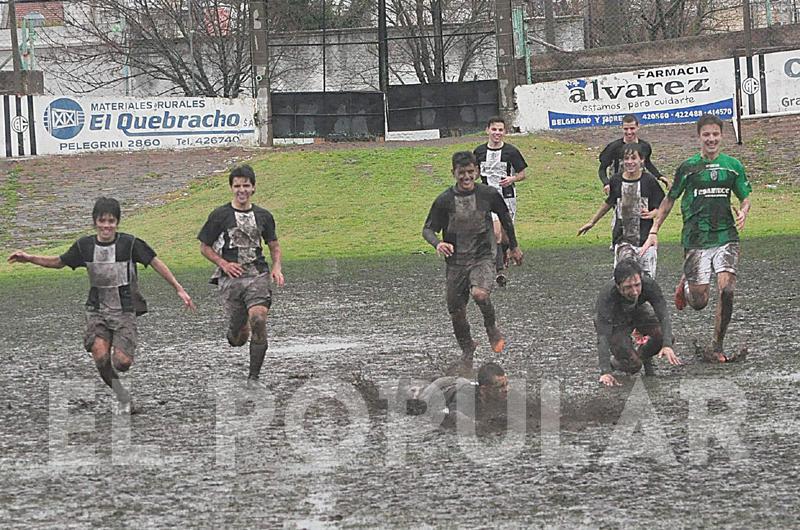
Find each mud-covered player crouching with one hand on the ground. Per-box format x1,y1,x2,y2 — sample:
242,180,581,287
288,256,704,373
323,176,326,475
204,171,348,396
594,259,682,386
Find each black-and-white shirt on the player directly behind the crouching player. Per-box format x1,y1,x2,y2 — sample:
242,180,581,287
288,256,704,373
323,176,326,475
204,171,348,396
606,173,664,247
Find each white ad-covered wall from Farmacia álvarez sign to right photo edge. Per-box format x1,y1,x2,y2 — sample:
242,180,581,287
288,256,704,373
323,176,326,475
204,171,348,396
515,49,800,132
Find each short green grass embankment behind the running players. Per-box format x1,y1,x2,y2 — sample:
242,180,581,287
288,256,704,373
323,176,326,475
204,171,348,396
0,132,800,279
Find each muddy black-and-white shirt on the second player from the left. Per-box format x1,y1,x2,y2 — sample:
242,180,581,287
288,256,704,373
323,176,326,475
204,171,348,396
197,203,278,283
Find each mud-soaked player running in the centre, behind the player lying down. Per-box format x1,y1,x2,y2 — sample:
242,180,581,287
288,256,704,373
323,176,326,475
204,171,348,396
422,151,522,370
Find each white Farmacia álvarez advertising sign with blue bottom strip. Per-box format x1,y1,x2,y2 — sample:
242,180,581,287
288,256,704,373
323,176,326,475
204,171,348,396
516,59,735,132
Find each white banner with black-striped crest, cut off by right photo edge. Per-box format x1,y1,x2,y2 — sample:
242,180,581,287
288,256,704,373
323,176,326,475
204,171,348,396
736,50,800,116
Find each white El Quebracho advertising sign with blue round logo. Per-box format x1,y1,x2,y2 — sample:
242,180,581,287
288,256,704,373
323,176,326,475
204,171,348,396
34,96,258,154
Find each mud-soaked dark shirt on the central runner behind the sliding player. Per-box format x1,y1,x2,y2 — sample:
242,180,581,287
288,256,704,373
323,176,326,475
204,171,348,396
422,184,517,265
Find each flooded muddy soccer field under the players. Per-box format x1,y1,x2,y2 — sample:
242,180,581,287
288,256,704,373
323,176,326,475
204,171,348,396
0,238,800,528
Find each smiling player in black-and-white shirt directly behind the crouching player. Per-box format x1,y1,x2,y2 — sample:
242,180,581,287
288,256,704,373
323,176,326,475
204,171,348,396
578,143,664,278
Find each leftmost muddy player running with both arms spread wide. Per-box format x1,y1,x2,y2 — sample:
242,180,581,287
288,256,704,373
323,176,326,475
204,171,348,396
8,197,194,413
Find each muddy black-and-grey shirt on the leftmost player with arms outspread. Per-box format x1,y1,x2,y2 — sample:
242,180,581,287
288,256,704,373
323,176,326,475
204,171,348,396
59,233,156,313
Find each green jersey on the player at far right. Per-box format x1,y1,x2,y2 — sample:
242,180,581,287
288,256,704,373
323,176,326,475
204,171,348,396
667,153,752,248
